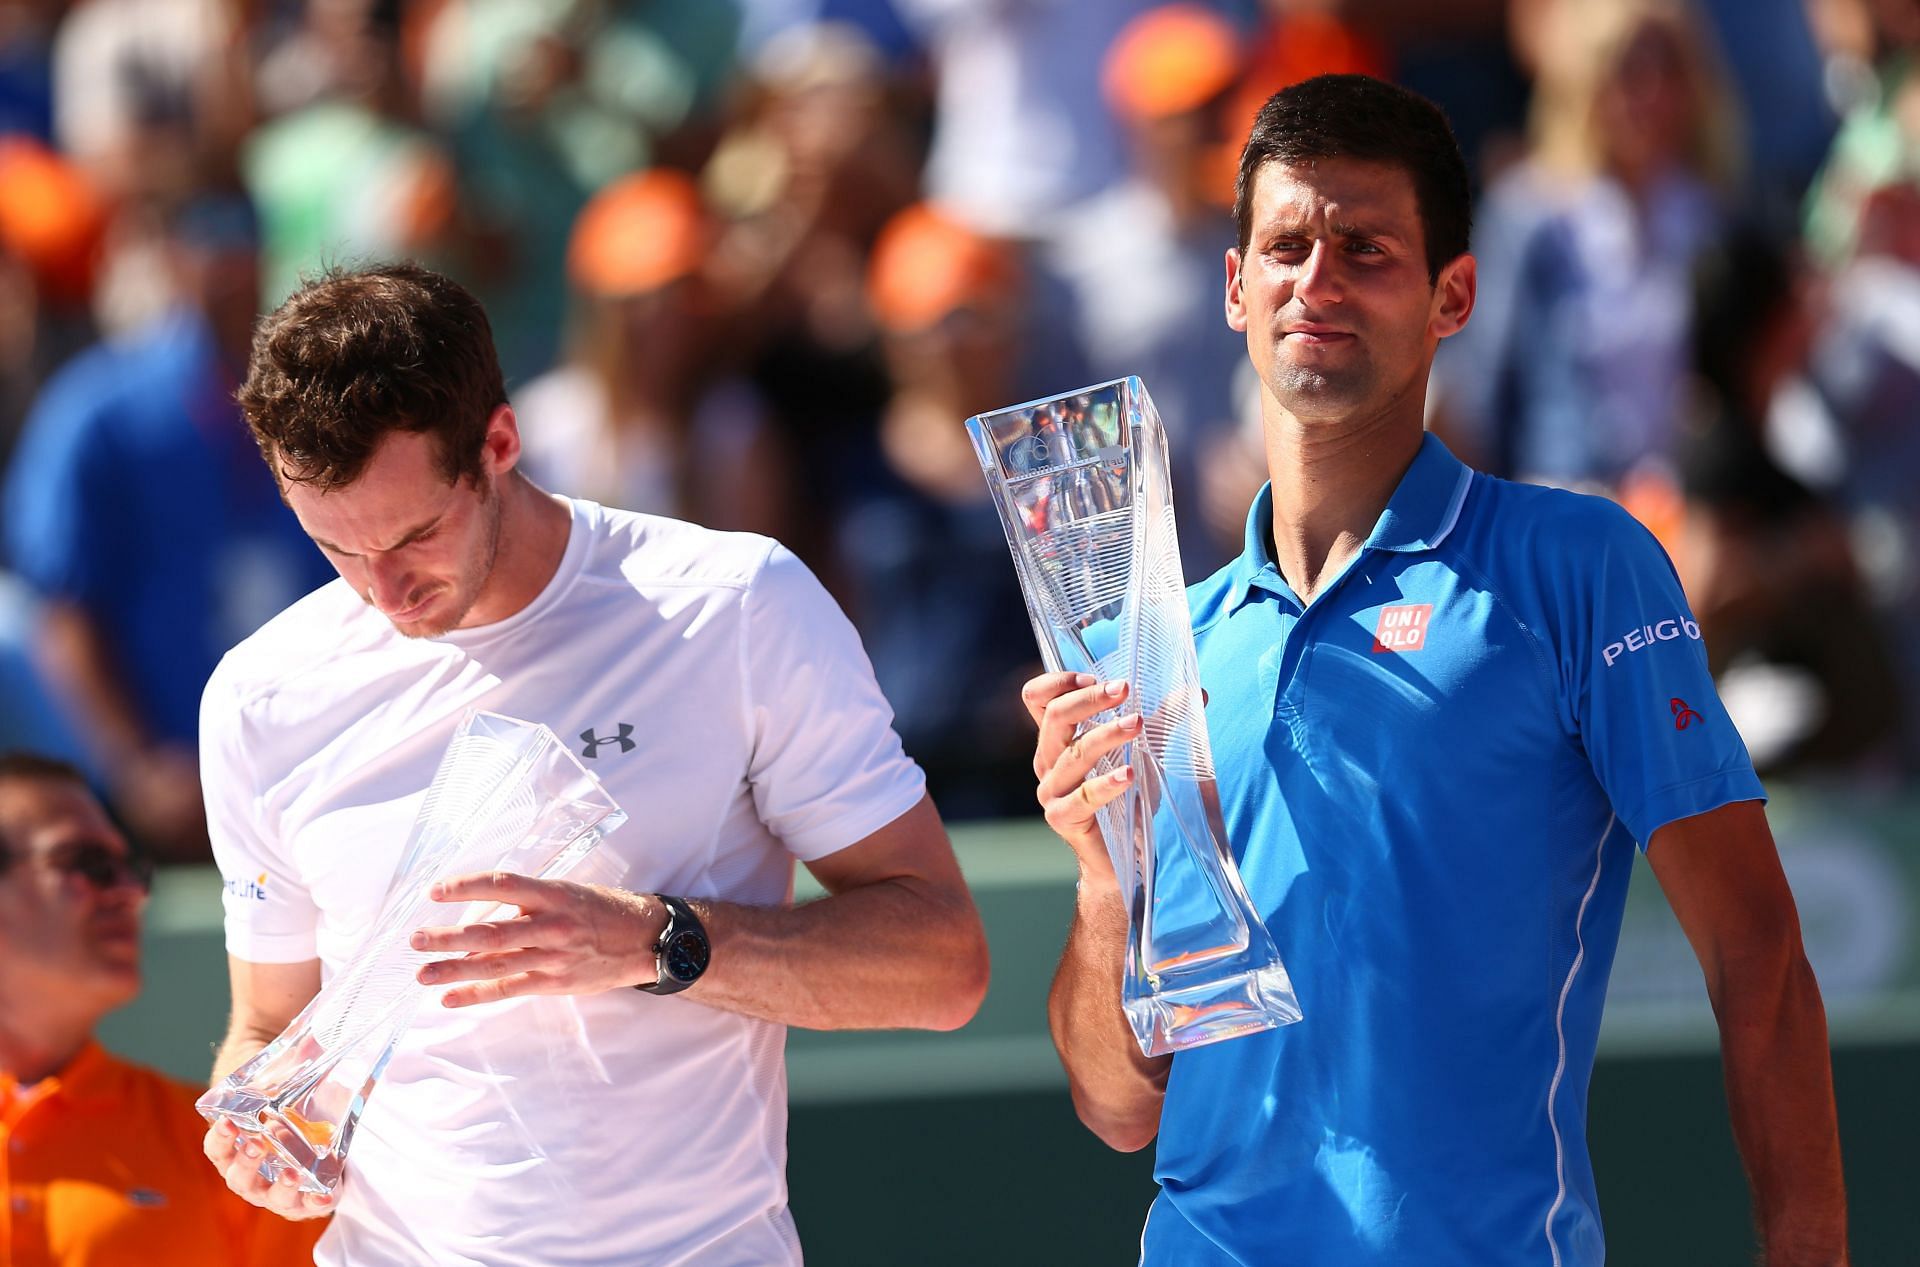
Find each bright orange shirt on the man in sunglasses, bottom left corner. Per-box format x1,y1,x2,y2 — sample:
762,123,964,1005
0,1042,326,1267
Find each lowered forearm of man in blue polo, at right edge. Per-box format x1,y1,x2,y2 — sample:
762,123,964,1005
1715,939,1847,1267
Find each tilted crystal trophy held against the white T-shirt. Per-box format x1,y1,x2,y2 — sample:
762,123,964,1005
198,712,626,1194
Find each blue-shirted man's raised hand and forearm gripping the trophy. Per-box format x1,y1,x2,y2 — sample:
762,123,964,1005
1021,674,1173,1152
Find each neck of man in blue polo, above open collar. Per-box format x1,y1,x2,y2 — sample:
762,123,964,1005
1263,395,1423,603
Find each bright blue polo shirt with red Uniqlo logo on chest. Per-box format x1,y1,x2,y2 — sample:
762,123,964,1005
1142,436,1764,1267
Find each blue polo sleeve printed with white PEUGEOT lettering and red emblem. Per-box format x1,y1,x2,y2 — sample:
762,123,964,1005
1551,497,1766,849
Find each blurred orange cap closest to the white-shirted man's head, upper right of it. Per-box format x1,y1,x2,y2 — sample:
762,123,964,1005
566,167,712,298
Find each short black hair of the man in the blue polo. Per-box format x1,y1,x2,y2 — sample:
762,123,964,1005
1233,75,1473,282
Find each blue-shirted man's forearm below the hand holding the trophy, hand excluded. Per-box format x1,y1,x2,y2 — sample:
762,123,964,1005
1046,879,1171,1152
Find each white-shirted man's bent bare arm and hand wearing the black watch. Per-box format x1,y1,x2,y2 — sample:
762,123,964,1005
413,799,987,1029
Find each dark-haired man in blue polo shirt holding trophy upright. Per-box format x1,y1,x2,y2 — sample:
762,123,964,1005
1025,77,1845,1267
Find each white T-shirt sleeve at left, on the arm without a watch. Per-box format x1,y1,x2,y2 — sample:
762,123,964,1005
200,672,319,964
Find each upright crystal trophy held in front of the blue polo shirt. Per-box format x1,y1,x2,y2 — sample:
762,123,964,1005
966,378,1300,1056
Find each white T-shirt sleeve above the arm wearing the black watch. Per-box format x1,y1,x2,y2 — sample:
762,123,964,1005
741,545,925,862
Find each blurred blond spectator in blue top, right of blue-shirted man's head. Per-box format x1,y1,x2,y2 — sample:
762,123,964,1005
1436,0,1738,490
